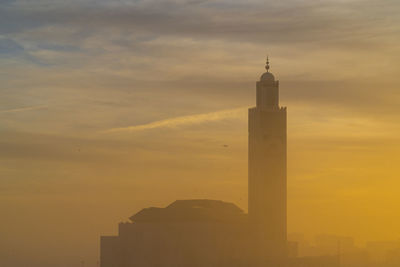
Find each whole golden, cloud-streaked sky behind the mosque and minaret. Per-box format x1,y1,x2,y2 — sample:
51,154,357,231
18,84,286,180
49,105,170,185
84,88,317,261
0,0,400,267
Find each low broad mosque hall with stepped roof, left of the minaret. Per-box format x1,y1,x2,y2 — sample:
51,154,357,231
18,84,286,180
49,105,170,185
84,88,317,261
101,200,249,267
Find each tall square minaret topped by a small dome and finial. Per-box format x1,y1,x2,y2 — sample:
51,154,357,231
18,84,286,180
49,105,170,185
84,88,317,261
248,59,287,256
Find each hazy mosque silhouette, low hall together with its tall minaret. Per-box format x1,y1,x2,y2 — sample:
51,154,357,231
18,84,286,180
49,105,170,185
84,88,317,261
100,60,338,267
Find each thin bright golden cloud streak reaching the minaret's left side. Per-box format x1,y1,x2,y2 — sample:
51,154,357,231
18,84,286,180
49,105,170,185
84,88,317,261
103,107,247,133
